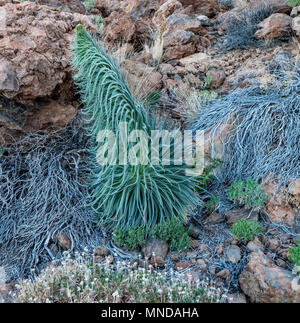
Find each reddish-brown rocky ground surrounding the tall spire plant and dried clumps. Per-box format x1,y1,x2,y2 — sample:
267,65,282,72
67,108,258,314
0,0,300,302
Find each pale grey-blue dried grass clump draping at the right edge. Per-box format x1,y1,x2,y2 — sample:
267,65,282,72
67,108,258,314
192,56,300,183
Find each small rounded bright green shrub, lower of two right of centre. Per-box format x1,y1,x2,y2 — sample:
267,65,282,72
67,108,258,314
231,219,262,241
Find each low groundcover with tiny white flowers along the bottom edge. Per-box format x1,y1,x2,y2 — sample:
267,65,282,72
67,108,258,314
15,255,226,303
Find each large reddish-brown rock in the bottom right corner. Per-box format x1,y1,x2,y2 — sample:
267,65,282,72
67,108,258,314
239,251,300,303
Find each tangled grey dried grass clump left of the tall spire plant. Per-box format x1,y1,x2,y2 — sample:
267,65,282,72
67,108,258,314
0,116,101,280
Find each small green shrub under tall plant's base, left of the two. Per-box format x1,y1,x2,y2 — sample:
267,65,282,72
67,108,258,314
113,226,146,250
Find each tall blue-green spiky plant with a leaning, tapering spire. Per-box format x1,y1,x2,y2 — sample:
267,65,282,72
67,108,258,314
73,25,197,230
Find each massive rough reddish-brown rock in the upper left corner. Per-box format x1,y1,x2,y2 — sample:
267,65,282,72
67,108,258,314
0,1,94,103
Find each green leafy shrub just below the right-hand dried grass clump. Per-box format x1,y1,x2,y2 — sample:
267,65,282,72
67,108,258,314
227,178,267,209
